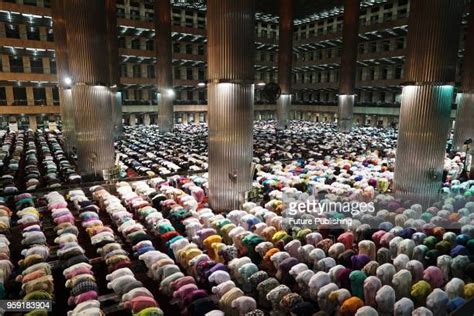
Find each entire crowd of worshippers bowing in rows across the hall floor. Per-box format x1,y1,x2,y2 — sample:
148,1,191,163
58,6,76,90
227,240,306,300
0,122,474,316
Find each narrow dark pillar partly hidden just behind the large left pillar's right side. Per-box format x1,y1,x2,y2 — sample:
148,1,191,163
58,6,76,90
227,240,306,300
105,0,123,139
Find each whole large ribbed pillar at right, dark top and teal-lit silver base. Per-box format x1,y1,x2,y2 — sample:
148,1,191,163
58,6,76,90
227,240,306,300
394,0,464,204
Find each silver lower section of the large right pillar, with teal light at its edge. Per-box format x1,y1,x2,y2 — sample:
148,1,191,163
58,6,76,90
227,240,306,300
395,85,453,202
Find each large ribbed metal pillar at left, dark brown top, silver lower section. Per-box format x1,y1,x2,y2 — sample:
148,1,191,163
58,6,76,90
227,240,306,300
64,0,115,179
